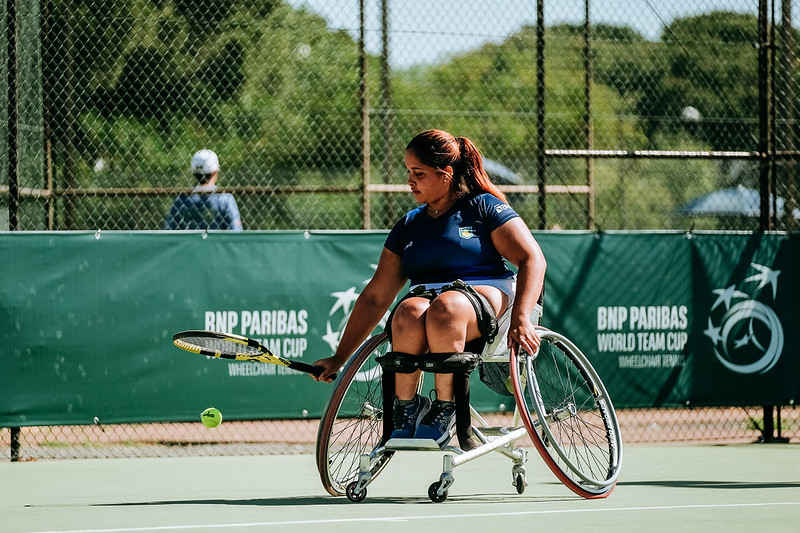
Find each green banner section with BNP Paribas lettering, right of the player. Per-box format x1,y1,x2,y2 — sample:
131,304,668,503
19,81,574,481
538,233,693,407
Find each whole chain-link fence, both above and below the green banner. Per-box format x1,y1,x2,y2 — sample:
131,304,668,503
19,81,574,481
0,0,800,458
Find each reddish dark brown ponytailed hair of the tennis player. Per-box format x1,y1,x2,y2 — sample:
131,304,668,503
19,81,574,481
406,130,508,203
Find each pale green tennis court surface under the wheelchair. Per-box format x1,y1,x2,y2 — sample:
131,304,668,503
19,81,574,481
0,444,800,533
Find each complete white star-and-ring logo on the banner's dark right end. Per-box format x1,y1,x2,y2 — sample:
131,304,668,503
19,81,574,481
703,263,784,374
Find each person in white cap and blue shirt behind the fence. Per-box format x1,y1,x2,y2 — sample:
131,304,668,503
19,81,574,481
164,149,242,231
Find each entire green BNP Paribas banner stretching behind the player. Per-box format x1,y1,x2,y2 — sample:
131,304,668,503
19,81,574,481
0,232,800,427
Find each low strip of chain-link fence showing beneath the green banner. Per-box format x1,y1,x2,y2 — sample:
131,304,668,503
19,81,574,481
0,406,800,461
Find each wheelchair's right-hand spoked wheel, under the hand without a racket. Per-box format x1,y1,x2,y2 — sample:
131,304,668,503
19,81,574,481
510,327,622,498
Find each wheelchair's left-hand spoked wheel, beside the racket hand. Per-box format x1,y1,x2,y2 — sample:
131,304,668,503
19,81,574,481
316,333,393,496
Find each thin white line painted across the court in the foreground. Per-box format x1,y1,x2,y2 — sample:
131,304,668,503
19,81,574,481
28,502,800,533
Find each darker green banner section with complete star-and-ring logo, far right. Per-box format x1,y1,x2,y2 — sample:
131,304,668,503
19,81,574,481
688,234,800,405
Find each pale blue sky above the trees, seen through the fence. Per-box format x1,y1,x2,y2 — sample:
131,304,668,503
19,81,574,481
289,0,760,68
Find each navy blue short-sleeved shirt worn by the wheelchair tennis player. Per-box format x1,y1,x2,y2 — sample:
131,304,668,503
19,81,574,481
384,193,519,286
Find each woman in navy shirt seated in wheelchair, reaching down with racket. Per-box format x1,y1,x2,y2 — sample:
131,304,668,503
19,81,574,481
314,130,546,447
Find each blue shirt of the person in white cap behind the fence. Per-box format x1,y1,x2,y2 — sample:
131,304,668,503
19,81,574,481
164,185,242,231
